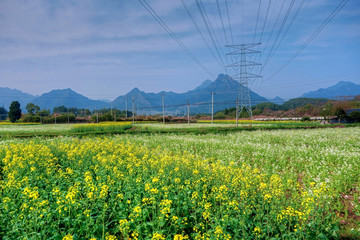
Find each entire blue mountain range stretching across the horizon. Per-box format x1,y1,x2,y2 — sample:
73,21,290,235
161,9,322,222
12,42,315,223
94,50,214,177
0,74,360,114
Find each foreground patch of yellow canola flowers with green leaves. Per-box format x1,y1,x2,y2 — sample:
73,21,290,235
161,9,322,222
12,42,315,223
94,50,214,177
0,138,329,240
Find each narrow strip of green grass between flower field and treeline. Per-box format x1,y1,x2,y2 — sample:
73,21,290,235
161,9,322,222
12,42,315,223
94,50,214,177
0,122,360,138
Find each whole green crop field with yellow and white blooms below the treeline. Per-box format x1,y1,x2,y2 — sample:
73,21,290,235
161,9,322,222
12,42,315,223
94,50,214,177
0,123,360,240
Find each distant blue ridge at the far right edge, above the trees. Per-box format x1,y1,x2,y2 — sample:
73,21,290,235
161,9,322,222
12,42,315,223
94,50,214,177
301,81,360,99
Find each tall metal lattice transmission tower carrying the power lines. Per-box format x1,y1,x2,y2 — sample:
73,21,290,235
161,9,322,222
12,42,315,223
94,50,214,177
225,43,262,119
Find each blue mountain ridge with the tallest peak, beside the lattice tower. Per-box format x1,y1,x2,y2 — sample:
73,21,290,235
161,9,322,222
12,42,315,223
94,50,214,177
112,74,268,114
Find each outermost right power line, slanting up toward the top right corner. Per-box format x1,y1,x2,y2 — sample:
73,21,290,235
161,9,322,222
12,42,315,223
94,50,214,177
268,0,349,80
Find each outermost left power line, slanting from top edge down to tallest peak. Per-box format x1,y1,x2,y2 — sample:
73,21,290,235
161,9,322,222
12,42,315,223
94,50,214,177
138,0,214,76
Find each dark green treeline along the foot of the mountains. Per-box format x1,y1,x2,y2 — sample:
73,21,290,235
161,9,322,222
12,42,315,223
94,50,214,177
0,95,360,123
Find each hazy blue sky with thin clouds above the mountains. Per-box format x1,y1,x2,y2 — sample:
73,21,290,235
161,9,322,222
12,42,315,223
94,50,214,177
0,0,360,100
